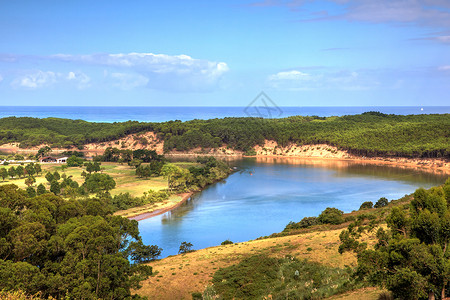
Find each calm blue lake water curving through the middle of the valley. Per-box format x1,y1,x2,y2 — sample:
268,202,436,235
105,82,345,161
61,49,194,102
139,158,446,257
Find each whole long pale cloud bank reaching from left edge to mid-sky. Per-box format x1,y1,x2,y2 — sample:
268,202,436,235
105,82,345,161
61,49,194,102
0,52,229,92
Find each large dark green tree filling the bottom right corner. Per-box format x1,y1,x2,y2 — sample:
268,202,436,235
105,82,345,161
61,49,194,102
339,180,450,299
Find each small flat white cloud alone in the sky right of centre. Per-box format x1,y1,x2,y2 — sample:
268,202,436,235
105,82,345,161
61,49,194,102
268,70,379,91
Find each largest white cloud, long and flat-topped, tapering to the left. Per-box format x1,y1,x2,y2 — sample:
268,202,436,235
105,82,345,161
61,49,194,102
49,53,229,91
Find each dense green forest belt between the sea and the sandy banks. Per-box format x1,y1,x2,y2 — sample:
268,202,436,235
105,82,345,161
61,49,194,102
0,112,450,158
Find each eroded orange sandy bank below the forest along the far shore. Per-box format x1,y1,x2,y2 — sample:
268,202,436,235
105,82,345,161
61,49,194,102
0,132,450,174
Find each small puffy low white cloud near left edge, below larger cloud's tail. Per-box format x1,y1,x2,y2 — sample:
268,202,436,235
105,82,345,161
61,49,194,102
11,70,90,89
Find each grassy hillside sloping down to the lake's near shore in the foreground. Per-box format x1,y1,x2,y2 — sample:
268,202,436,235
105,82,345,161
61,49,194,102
138,196,411,300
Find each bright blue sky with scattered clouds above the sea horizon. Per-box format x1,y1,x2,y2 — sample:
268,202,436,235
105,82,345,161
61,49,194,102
0,0,450,106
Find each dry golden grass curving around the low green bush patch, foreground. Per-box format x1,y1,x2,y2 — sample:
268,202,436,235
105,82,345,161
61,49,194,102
137,229,356,299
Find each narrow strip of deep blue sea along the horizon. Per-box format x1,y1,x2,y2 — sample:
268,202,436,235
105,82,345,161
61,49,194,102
0,106,450,123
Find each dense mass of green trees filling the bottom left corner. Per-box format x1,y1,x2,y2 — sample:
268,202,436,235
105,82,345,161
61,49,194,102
0,184,161,299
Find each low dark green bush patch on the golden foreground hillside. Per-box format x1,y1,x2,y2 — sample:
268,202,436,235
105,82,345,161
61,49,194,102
211,255,351,299
